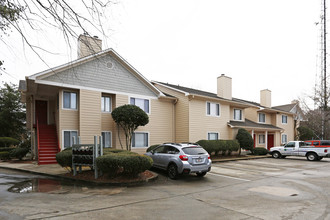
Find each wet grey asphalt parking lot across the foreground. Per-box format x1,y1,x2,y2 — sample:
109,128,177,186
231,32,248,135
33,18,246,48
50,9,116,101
0,157,330,219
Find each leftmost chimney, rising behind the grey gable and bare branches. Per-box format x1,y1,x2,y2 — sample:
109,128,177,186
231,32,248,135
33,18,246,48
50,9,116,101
78,34,102,59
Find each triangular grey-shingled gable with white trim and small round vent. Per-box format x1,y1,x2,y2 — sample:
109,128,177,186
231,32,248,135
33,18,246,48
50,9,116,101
28,49,164,97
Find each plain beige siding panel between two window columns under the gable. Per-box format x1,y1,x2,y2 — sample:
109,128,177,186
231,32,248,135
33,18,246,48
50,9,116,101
79,89,101,144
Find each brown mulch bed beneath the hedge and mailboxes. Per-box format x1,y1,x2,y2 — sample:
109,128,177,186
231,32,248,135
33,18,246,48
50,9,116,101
62,170,155,184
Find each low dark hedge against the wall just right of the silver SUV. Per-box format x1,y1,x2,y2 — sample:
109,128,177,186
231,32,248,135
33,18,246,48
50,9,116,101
197,140,239,155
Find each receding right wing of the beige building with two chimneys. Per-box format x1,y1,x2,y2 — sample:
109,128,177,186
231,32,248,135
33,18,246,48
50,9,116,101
153,75,294,149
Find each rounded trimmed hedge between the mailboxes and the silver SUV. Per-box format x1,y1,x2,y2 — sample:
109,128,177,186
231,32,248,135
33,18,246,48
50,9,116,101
96,153,153,176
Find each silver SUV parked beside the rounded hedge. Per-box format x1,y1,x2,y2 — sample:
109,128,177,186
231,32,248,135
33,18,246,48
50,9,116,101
145,143,212,179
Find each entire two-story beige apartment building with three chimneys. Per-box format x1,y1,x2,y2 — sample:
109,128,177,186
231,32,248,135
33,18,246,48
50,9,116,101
19,35,295,164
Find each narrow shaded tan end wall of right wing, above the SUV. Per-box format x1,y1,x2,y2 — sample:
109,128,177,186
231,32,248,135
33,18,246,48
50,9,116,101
155,84,189,142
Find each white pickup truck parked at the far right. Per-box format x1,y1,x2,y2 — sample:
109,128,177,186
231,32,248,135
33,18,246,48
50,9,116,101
269,141,330,161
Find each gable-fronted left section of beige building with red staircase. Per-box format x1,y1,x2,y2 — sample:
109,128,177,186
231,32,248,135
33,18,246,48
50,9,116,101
20,35,176,164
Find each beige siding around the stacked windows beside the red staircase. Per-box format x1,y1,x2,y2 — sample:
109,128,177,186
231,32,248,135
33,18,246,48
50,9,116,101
58,89,80,149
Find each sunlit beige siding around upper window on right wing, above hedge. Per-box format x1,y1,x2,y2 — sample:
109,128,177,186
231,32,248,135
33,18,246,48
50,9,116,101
189,98,232,142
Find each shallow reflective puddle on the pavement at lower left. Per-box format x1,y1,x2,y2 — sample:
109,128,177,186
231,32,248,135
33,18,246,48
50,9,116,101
8,178,125,195
